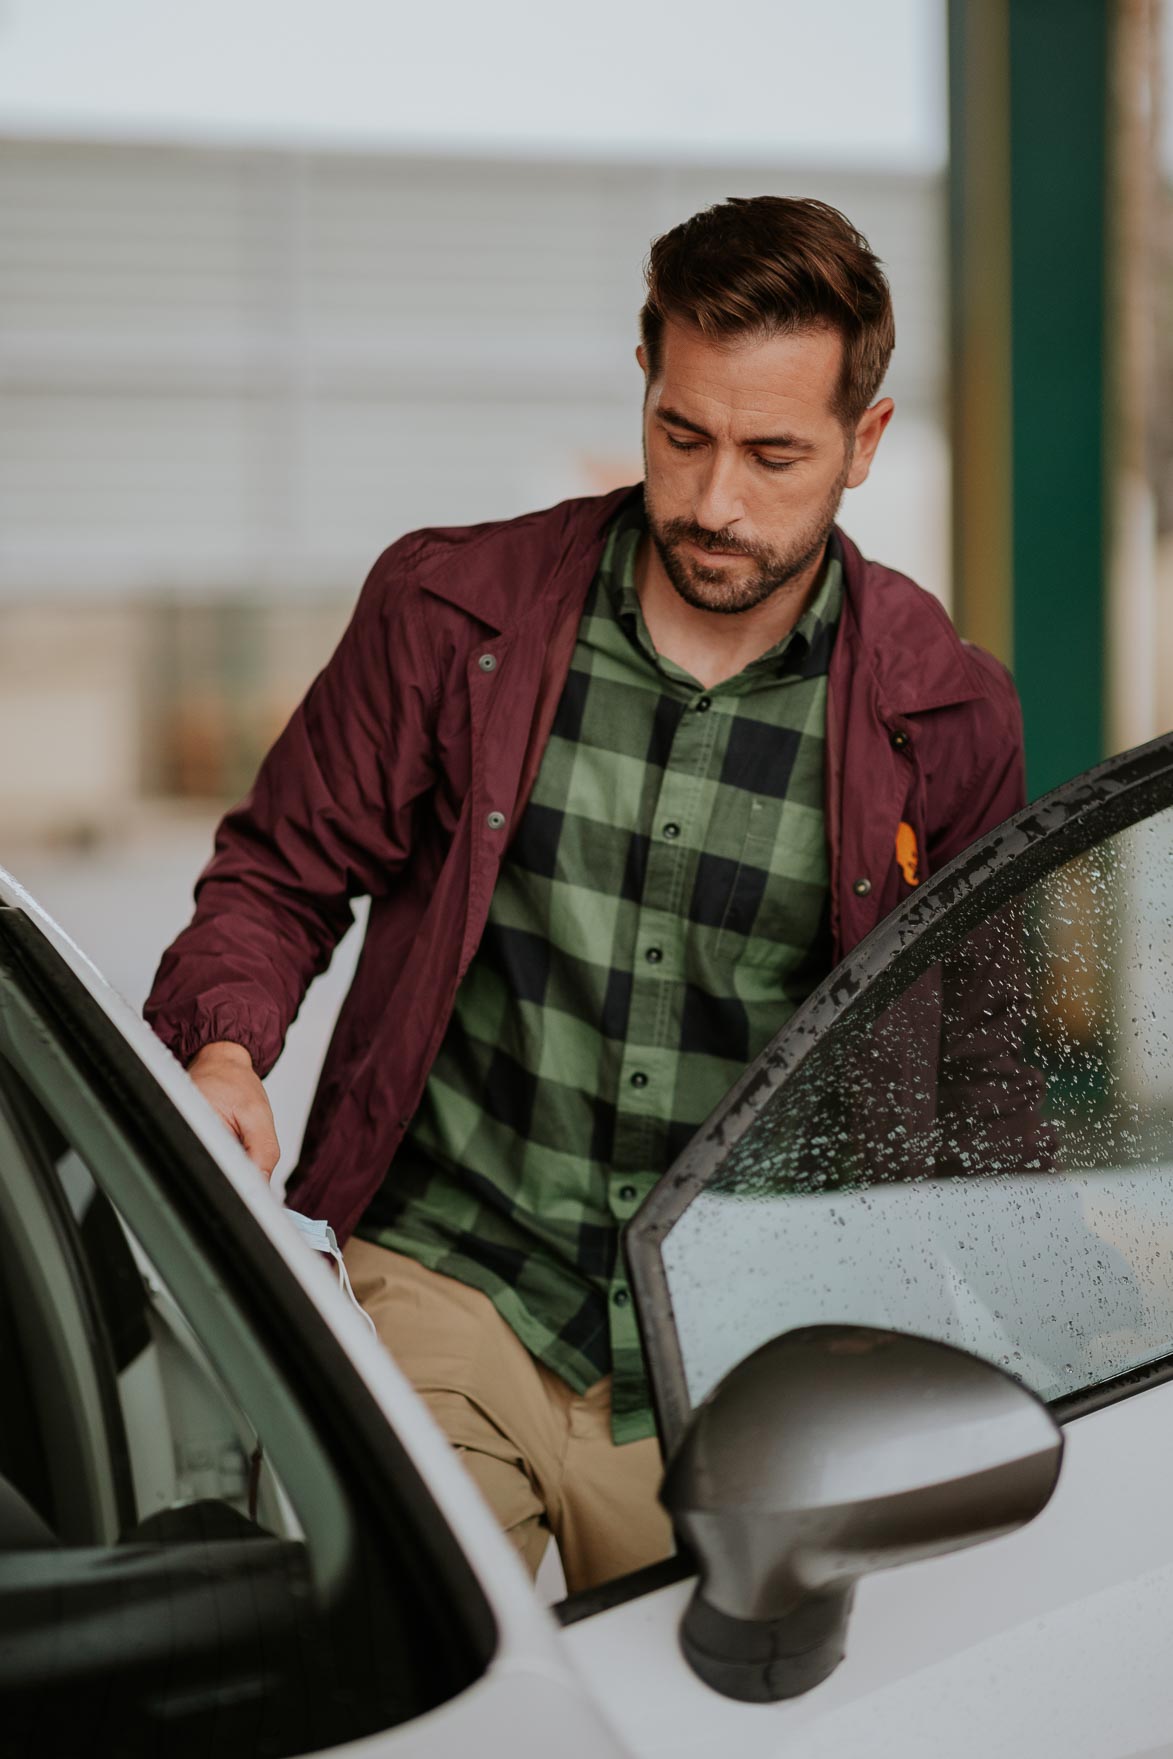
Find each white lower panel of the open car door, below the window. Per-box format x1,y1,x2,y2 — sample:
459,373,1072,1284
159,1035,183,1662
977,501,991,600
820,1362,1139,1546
565,1383,1173,1759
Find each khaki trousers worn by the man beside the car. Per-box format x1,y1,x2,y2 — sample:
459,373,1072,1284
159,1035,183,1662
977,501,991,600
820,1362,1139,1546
343,1240,674,1594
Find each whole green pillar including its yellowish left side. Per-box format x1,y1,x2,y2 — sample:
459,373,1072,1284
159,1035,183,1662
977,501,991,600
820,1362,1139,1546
950,0,1113,795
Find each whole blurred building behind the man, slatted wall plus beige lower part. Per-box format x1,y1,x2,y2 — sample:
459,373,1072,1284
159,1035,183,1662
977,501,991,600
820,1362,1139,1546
0,139,948,839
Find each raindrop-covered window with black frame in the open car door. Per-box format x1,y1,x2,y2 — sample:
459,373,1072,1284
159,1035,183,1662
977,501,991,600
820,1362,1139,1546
630,739,1173,1449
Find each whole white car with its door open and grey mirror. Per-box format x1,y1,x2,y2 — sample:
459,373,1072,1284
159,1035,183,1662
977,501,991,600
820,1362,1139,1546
0,735,1173,1759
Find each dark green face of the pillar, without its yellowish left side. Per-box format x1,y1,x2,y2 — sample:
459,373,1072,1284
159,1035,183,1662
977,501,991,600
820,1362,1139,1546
1009,0,1110,793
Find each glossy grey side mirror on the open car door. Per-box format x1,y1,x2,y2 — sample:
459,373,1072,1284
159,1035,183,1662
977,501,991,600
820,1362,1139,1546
659,1325,1062,1703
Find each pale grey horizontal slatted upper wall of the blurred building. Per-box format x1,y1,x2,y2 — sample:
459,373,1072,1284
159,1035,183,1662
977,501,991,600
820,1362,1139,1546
0,141,943,602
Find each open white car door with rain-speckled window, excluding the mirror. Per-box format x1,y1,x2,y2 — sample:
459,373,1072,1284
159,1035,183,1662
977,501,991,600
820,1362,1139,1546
565,735,1173,1759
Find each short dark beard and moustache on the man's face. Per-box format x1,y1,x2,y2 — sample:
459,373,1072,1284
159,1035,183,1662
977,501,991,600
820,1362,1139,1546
644,457,851,616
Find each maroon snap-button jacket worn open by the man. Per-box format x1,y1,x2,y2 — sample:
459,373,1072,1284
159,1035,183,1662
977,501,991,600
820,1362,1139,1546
146,489,1024,1240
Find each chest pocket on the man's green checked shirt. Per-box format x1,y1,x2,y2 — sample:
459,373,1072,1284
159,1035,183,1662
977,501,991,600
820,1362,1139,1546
716,795,828,967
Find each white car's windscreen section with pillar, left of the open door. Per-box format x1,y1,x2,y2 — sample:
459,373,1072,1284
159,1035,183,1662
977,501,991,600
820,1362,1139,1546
0,876,623,1759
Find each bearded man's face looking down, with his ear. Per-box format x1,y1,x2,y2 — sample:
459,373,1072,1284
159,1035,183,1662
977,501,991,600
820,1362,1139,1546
638,320,892,612
